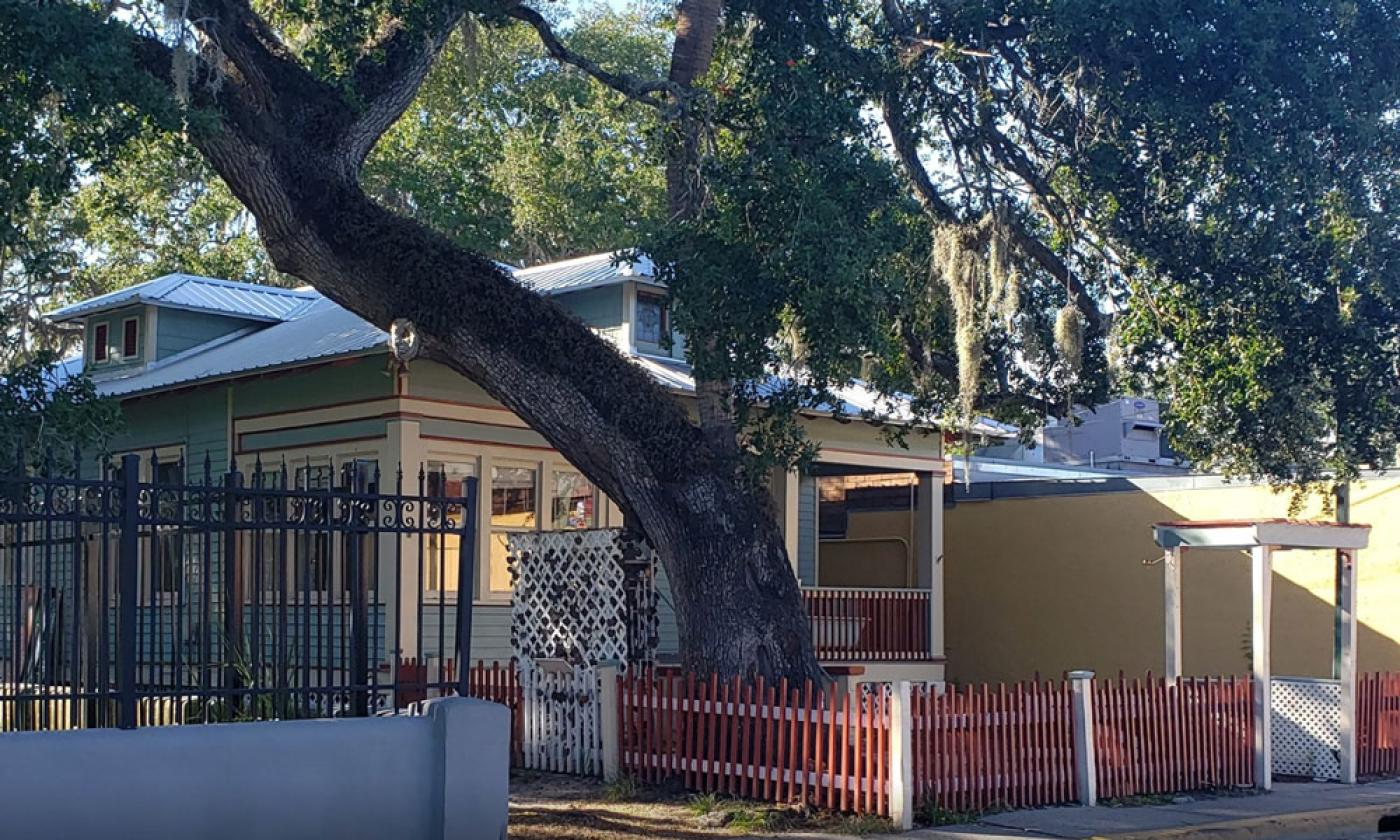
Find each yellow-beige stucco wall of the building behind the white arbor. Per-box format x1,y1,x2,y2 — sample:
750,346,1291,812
944,477,1400,682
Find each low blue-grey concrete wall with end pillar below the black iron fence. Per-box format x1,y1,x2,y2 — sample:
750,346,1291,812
0,699,510,840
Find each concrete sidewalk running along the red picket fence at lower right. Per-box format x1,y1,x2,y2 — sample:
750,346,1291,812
884,781,1400,840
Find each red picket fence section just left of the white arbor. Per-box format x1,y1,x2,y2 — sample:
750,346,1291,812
1093,675,1254,799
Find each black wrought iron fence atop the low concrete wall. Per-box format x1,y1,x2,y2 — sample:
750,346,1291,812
0,455,476,731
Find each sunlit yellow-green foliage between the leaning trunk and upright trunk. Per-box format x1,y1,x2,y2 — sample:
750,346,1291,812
364,6,666,265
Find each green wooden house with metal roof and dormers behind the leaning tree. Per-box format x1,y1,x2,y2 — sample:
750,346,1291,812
50,253,945,679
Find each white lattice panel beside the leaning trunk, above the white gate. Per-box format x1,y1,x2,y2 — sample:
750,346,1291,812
508,528,659,668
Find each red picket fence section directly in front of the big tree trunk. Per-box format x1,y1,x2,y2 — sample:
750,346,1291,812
617,673,889,815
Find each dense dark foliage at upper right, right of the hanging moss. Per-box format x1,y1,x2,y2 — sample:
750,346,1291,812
872,0,1400,483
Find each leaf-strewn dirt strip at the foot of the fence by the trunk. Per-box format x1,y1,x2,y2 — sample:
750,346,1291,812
510,771,889,840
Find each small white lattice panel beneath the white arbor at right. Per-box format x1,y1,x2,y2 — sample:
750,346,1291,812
1271,676,1341,781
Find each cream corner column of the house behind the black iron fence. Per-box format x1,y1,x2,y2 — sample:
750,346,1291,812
379,420,426,658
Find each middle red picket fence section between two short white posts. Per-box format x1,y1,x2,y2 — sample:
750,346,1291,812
911,682,1075,812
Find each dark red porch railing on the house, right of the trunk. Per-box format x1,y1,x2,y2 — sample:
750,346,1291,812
802,587,932,661
